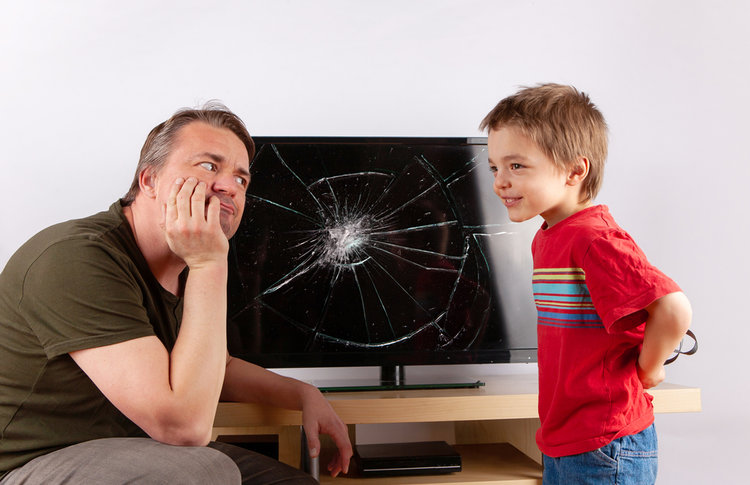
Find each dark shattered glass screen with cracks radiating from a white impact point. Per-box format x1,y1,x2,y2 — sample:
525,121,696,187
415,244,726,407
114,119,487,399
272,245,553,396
230,140,524,351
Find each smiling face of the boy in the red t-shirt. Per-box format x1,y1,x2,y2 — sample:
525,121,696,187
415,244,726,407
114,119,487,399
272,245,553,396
487,126,588,227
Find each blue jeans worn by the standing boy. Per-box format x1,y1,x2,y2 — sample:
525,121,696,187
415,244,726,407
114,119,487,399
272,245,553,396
542,424,658,485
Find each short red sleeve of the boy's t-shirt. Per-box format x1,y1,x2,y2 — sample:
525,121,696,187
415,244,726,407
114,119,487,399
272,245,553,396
583,230,680,332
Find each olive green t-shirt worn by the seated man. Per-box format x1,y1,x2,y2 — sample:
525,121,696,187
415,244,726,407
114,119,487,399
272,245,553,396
0,202,182,477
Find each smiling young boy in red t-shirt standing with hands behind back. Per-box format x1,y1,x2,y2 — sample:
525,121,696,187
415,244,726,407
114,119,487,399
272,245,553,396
480,84,691,485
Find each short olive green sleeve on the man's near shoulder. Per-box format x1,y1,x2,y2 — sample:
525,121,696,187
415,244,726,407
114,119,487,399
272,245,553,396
19,239,154,358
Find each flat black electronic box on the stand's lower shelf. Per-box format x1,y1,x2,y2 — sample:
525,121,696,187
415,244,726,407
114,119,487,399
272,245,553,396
353,441,461,477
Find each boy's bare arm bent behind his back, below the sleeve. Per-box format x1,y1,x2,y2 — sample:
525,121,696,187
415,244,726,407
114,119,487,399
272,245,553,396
638,291,692,389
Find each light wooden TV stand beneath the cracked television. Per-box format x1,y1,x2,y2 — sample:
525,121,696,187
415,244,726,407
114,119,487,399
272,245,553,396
213,374,701,485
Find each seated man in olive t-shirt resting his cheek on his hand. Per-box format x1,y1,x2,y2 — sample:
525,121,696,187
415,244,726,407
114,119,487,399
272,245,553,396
0,104,352,485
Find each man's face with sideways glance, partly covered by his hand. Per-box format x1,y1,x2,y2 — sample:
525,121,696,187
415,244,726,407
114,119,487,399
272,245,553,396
154,121,250,238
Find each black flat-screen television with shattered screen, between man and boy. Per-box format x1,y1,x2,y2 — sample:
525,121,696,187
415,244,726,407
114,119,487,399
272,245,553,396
227,137,539,386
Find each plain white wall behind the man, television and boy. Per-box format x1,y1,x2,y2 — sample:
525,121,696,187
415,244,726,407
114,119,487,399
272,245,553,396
0,0,750,484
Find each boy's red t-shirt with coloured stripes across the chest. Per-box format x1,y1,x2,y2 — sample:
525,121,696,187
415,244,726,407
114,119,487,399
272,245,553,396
531,205,680,457
